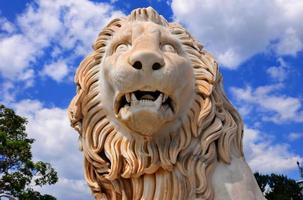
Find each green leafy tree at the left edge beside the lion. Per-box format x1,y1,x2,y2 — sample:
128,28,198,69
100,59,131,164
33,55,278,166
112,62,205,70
0,104,58,200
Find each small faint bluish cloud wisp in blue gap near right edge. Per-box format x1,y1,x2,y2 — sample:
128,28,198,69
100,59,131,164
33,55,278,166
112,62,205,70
266,58,289,82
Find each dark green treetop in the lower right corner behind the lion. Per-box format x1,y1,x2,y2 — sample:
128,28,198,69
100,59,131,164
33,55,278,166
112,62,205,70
255,173,303,200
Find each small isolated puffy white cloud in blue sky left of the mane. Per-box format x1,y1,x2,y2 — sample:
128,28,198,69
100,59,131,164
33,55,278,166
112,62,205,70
41,60,69,82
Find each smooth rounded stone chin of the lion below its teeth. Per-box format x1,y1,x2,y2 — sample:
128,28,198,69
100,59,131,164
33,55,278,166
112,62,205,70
118,104,173,139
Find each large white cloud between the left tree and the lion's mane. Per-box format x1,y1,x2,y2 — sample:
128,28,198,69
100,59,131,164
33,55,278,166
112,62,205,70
12,99,92,200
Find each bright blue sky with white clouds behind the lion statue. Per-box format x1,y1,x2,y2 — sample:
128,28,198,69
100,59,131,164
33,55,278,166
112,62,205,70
0,0,303,199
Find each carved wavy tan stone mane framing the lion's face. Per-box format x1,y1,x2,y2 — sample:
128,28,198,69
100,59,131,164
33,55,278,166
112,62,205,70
69,8,243,199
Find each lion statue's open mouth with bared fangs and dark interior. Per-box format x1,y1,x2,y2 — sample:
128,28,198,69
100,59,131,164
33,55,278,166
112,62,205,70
115,90,175,114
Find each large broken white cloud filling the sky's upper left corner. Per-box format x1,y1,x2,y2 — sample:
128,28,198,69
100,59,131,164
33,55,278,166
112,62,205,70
0,0,123,81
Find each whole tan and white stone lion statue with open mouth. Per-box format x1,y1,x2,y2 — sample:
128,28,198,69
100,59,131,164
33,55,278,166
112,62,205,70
68,7,264,200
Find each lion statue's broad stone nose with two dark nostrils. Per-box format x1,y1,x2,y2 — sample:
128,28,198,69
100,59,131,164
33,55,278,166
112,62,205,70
129,51,164,71
